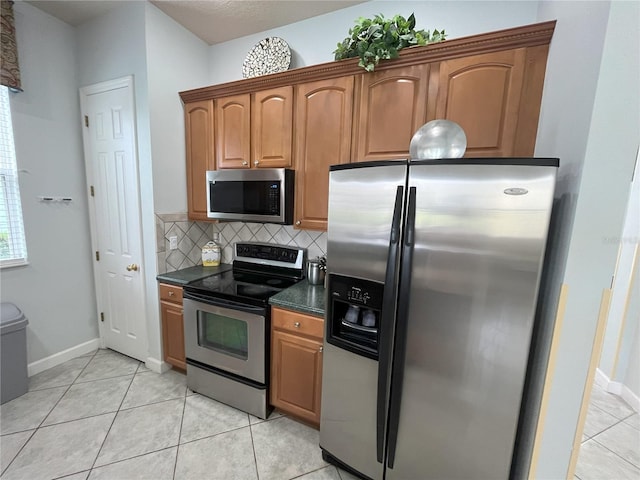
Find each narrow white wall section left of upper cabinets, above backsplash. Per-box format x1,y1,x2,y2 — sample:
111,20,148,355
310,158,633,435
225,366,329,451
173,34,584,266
146,3,209,213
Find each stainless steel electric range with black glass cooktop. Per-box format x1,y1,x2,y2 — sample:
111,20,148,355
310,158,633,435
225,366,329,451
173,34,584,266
183,242,306,418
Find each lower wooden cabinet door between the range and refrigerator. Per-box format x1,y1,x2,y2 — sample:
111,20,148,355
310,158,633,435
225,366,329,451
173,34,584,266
271,330,322,424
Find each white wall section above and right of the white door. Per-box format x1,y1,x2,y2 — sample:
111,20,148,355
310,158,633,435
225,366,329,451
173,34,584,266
76,1,162,361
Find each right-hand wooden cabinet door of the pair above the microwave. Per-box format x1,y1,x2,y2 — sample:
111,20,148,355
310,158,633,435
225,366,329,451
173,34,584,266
251,87,293,168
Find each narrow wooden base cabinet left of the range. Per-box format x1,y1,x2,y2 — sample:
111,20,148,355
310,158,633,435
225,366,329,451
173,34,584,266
160,283,187,370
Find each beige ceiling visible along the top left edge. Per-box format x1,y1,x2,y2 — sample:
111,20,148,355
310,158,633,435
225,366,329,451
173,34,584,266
28,0,364,45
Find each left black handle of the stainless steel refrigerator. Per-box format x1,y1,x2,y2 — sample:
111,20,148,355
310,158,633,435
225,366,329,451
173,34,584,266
376,185,404,463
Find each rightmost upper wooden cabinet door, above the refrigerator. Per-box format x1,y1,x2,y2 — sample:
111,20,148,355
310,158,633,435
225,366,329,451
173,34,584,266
436,48,526,157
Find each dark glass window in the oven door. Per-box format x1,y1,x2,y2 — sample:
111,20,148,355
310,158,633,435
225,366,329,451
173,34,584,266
198,311,248,360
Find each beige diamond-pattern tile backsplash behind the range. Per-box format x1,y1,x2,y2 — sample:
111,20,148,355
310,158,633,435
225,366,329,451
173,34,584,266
156,213,327,273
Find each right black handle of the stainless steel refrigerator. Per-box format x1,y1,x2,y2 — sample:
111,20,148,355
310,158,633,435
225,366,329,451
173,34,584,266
387,187,416,468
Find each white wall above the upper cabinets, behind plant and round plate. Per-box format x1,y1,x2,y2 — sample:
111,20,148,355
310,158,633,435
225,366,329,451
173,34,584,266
209,1,538,84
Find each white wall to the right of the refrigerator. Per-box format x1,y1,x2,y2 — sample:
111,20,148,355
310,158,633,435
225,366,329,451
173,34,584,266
524,1,640,478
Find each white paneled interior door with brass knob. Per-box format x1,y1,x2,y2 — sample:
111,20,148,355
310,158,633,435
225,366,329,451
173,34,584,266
80,77,147,361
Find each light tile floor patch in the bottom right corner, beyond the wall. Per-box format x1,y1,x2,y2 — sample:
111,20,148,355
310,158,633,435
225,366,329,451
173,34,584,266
575,384,640,480
